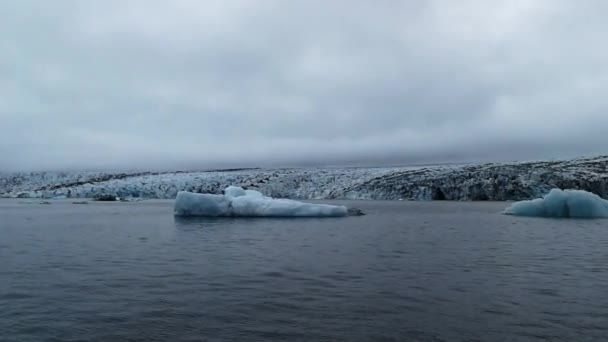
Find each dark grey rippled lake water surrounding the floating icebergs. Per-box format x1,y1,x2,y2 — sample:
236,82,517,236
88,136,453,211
0,200,608,342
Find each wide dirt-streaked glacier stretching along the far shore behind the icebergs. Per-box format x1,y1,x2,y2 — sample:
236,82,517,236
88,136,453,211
0,156,608,201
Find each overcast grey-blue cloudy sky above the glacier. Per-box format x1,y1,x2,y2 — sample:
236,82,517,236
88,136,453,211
0,0,608,171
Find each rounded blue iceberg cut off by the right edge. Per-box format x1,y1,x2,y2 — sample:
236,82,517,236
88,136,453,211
504,189,608,218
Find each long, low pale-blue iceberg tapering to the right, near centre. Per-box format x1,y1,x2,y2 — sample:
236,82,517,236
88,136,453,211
174,186,350,217
